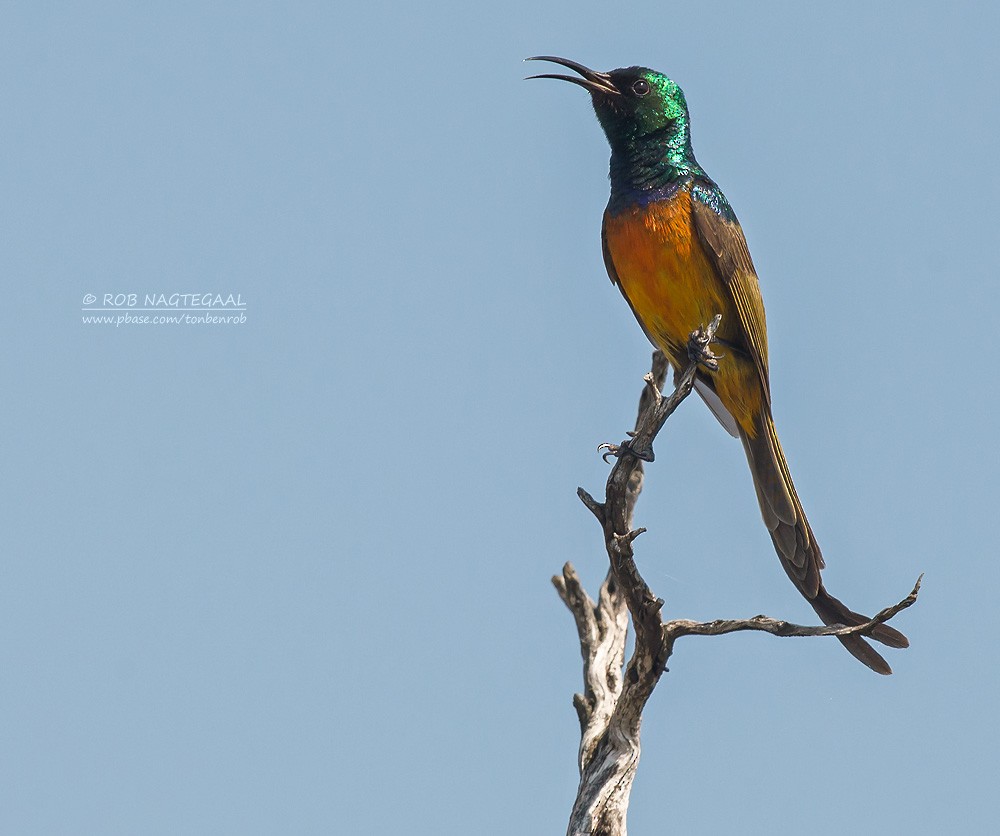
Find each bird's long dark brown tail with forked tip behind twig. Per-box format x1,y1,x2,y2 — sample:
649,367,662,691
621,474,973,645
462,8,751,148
740,410,910,674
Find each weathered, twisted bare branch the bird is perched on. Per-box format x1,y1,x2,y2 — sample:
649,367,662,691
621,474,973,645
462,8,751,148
552,316,920,836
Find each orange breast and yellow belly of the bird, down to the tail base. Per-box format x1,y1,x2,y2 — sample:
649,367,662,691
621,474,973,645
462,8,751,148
604,188,763,435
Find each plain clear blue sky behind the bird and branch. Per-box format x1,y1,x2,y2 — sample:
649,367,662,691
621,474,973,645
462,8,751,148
0,0,1000,836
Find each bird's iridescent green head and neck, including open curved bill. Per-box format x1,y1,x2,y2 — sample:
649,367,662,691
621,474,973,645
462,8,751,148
528,55,698,183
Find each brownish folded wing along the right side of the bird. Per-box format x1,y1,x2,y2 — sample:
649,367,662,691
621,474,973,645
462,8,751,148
691,199,771,401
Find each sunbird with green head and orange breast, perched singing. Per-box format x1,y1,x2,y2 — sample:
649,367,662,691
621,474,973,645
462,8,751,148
525,55,909,674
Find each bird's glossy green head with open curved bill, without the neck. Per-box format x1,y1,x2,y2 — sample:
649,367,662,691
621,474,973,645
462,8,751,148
526,55,688,151
